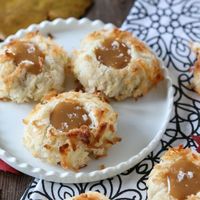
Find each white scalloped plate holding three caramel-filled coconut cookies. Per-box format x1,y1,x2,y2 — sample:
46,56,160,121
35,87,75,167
0,18,173,183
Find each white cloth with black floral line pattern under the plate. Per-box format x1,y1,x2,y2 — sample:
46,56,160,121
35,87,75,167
21,0,200,200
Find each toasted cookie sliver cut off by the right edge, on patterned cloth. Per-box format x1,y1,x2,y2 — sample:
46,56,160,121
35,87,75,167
192,43,200,94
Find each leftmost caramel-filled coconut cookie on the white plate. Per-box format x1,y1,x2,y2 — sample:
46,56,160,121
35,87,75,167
0,32,68,103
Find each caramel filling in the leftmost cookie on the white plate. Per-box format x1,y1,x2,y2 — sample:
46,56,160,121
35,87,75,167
6,41,45,75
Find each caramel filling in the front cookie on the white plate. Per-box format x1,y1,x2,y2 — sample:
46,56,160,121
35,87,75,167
50,102,91,132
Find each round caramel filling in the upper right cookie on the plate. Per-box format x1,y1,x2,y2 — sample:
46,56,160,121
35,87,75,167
95,39,131,69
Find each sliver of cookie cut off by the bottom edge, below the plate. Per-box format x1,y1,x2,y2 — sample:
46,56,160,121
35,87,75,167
69,192,109,200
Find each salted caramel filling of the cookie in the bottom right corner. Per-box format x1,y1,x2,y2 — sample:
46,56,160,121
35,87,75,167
167,158,200,200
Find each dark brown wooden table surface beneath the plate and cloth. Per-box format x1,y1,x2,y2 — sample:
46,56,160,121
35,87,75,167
0,0,133,200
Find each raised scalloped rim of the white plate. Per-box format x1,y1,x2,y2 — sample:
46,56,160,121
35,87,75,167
0,18,173,183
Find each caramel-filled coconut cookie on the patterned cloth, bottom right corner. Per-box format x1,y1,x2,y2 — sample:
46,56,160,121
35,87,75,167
147,146,200,200
